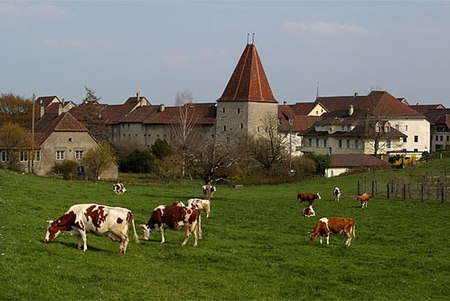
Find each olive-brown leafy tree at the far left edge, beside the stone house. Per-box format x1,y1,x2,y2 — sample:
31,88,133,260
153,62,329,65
0,122,31,170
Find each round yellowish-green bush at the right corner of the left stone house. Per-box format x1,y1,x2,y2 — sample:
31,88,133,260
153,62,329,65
81,143,117,180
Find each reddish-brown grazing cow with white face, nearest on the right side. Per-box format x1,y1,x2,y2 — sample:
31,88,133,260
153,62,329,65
309,217,356,247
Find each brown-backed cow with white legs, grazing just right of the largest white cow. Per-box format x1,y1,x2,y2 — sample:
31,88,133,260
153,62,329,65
141,202,201,247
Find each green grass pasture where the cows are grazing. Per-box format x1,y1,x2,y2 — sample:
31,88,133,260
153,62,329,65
0,160,450,300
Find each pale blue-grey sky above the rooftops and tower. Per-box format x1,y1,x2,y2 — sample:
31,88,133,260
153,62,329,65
0,0,450,108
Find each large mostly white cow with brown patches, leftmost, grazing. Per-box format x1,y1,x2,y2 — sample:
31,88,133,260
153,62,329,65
44,204,139,254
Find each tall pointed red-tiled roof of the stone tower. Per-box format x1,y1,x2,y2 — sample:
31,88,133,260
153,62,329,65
217,44,277,103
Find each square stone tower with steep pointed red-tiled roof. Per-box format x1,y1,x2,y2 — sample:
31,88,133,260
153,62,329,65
216,43,278,144
